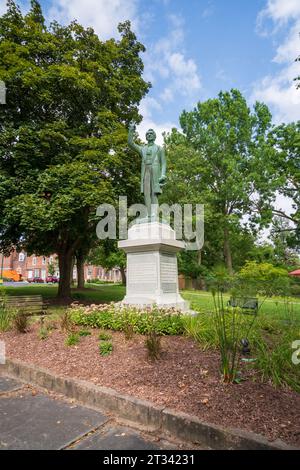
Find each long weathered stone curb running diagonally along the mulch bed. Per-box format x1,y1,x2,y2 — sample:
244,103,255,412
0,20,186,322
0,359,296,450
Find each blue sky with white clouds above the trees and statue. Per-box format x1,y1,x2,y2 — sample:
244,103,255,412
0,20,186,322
0,0,300,140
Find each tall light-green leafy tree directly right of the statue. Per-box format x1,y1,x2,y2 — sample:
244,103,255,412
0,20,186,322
166,90,276,273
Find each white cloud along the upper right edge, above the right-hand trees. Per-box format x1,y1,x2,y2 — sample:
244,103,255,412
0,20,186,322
251,0,300,122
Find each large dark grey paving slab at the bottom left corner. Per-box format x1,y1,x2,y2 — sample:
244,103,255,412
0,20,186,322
0,394,108,450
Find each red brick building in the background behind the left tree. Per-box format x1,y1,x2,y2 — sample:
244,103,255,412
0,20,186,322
0,251,121,282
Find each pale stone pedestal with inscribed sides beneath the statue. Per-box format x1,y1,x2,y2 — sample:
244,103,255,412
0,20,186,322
118,222,188,311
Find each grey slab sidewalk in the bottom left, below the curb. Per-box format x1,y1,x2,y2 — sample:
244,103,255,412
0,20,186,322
0,376,180,450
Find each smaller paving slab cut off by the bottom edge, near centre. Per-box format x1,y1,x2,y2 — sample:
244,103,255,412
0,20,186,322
72,427,160,450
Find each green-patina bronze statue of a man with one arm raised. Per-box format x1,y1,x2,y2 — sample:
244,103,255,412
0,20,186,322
128,123,166,220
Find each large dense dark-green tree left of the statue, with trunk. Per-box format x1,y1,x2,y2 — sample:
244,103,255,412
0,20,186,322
0,0,149,297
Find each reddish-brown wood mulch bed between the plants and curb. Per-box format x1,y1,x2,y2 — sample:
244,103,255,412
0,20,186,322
0,324,300,446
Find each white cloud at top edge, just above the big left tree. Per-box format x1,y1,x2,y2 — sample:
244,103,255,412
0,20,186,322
48,0,138,39
